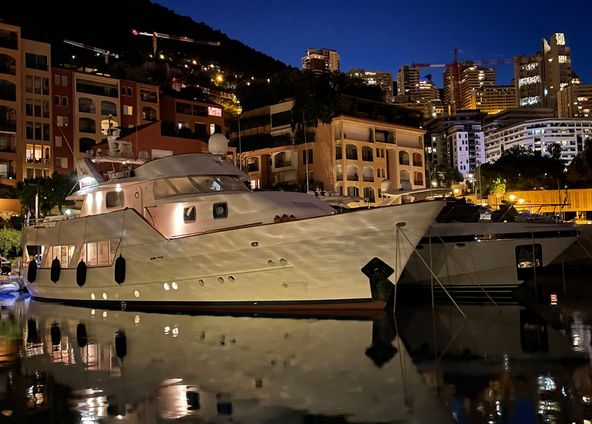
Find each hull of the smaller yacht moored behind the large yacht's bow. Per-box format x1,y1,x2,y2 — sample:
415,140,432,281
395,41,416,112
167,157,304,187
401,223,577,290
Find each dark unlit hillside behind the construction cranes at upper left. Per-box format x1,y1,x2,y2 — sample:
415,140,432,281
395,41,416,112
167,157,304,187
0,0,287,77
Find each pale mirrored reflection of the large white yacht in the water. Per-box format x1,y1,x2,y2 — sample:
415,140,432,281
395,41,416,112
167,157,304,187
13,300,452,423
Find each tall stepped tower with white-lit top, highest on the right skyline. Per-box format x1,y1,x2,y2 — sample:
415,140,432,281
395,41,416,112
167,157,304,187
514,32,575,109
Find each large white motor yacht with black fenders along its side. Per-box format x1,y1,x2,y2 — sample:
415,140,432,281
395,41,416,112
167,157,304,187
23,134,444,310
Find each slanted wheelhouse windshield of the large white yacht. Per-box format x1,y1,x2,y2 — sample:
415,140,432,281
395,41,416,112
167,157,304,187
154,175,249,199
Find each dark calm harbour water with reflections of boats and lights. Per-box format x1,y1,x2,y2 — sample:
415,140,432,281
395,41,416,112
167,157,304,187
0,268,592,424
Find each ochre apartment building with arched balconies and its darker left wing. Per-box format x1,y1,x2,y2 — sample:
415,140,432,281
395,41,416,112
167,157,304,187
231,101,425,203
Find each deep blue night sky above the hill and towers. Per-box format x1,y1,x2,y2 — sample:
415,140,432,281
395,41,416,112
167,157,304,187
153,0,592,86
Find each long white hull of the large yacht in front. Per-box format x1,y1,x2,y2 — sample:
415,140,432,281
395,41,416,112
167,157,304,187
24,202,443,310
